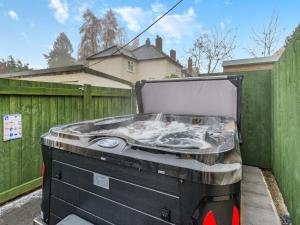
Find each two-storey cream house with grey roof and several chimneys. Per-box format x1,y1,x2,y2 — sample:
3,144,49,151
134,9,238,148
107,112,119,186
87,36,182,83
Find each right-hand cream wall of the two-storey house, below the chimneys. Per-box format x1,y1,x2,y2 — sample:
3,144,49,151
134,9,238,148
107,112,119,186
137,59,181,80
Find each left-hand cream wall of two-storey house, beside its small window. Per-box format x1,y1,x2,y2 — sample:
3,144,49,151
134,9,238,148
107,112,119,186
89,56,136,82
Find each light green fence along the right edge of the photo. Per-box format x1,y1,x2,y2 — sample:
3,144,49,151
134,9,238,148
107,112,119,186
272,27,300,225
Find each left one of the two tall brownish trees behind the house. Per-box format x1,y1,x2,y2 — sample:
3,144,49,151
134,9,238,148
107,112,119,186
78,9,102,62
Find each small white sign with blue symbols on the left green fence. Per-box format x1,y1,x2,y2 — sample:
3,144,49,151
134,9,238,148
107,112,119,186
3,114,22,141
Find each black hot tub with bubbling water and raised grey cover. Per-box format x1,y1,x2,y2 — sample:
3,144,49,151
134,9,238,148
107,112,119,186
38,76,242,225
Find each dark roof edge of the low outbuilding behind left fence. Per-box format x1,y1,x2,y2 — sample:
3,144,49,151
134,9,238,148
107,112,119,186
0,65,132,85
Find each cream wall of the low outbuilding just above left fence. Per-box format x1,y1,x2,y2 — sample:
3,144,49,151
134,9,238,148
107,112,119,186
15,72,131,89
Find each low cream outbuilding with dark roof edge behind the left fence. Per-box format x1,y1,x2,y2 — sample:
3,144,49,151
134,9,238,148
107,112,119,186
0,65,132,89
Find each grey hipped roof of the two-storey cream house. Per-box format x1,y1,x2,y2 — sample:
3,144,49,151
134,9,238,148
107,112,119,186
87,44,182,67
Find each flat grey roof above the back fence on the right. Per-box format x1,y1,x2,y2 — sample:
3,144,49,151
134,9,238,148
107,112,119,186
222,55,280,67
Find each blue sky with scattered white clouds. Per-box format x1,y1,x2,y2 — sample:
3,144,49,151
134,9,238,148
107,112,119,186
0,0,300,68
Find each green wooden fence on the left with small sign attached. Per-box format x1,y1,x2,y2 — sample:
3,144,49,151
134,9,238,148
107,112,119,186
0,79,136,204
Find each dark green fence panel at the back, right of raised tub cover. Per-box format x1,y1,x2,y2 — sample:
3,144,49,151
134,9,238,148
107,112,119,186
241,70,271,168
